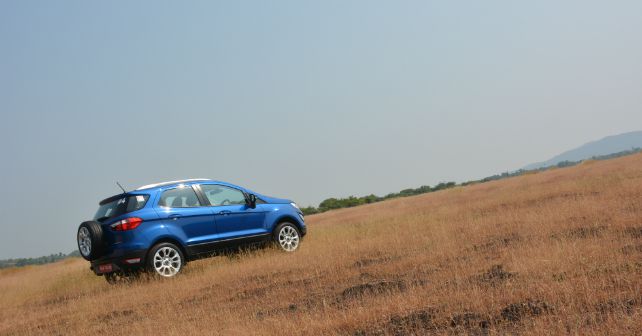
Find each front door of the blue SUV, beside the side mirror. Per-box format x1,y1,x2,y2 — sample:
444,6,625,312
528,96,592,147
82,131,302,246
199,184,267,240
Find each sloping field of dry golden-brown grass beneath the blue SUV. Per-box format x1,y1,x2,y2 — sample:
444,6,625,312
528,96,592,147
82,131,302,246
0,155,642,335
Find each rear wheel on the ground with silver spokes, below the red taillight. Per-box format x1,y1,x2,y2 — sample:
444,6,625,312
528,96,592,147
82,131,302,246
147,243,185,278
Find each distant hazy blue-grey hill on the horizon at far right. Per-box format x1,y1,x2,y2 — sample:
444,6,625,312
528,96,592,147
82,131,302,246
523,131,642,170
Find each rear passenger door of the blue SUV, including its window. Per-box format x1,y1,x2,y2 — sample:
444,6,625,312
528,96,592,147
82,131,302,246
158,185,217,246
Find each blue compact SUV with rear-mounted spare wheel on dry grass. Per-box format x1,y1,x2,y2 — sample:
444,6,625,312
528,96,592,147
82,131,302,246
76,179,307,283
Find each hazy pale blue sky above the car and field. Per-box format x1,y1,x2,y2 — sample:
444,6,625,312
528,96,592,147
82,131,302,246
0,0,642,258
